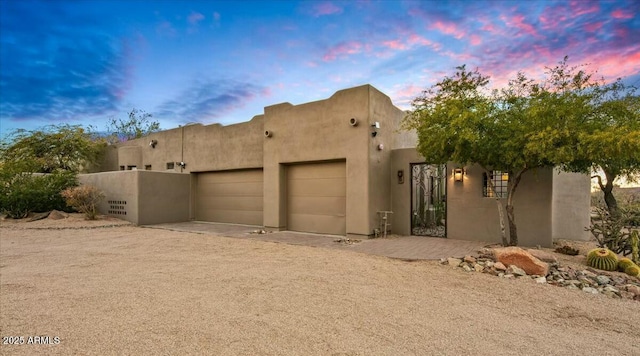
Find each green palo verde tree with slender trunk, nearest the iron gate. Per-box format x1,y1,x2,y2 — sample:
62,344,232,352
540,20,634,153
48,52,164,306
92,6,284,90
404,61,589,246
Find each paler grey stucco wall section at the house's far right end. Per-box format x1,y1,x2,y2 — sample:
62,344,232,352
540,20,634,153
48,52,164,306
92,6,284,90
552,170,591,241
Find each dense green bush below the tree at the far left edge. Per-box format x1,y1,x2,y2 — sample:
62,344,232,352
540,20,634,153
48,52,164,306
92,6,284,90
0,171,77,219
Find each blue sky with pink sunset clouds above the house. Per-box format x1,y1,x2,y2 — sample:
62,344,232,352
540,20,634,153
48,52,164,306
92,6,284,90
0,0,640,135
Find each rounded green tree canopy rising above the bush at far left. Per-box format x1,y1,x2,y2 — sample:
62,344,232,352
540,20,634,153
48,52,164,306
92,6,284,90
0,125,106,173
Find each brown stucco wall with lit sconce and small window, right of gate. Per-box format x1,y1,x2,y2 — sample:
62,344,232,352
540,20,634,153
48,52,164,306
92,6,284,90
447,165,553,247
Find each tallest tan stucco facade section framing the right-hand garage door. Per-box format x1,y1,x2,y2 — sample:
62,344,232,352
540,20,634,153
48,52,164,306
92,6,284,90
264,85,371,235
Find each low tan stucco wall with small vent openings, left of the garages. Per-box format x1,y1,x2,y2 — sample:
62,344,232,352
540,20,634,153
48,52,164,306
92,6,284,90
78,170,191,225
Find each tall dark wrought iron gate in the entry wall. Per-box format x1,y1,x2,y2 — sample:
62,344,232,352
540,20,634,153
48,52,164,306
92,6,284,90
411,163,447,237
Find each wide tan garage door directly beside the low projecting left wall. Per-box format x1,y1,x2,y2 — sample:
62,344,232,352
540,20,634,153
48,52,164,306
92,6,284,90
195,169,263,225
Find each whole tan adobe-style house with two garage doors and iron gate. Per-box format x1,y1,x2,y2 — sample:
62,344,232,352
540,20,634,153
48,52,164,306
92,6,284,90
81,85,590,246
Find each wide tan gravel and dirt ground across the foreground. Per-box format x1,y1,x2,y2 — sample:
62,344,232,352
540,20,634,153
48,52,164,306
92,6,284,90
0,217,640,355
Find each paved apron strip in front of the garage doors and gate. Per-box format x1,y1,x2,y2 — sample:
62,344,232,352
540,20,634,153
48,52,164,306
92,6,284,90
143,221,489,260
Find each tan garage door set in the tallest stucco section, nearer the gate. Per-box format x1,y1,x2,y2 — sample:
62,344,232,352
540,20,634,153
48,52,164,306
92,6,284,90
287,162,347,235
